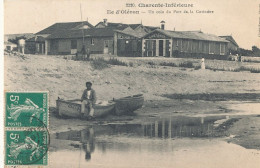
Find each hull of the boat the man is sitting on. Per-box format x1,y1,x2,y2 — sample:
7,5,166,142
56,99,115,118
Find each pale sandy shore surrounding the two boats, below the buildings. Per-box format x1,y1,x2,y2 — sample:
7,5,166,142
5,55,260,149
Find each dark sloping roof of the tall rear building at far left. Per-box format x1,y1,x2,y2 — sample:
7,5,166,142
36,21,94,35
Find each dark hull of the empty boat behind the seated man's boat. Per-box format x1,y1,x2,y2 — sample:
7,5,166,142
114,94,144,115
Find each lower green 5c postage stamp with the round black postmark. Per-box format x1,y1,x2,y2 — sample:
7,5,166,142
5,128,49,166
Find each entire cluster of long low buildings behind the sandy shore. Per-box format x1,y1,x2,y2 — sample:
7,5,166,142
28,19,229,59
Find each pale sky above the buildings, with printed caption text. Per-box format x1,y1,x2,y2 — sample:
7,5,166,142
4,0,260,49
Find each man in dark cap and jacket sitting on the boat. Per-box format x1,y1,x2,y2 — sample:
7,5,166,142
81,82,97,119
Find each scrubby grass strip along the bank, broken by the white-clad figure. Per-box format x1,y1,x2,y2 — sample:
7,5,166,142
90,55,260,73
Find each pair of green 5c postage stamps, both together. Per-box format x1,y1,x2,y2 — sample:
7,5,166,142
5,92,49,166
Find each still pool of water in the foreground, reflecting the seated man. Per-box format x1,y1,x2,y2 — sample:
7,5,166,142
49,116,260,168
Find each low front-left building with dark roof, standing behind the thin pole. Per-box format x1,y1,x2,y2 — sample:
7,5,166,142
45,28,114,54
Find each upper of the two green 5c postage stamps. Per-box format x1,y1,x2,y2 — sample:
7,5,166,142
5,92,48,128
